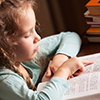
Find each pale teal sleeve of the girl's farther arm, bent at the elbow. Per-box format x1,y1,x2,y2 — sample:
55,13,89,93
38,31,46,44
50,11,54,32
39,32,81,57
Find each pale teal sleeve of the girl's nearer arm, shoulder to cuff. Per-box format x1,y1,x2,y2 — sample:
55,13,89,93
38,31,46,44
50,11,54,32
0,75,69,100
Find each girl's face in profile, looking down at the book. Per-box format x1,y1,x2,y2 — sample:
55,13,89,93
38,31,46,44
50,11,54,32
16,8,40,62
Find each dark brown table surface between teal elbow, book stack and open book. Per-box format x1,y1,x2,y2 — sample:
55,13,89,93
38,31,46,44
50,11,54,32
77,34,100,57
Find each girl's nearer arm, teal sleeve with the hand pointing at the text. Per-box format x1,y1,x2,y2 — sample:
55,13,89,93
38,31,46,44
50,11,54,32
0,57,93,100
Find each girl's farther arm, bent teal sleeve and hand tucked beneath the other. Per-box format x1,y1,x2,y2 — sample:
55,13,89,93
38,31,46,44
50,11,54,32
37,32,81,77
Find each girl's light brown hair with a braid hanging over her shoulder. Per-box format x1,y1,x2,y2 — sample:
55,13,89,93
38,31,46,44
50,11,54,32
0,0,36,89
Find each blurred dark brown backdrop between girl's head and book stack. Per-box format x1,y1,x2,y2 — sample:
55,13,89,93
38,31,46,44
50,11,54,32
36,0,89,38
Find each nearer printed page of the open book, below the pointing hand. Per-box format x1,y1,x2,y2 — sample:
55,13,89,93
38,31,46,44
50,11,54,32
64,72,100,100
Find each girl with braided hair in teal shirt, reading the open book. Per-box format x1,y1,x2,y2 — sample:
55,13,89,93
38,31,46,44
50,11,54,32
0,0,93,100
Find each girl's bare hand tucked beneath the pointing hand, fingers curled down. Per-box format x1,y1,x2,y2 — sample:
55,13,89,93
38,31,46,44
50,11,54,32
45,54,69,78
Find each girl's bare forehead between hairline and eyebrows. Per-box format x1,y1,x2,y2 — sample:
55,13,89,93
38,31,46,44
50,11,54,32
19,8,36,32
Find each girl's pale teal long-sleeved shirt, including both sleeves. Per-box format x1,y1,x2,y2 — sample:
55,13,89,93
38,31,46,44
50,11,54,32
0,32,81,100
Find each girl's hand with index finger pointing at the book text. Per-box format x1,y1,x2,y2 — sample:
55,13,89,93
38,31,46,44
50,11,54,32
53,57,94,80
